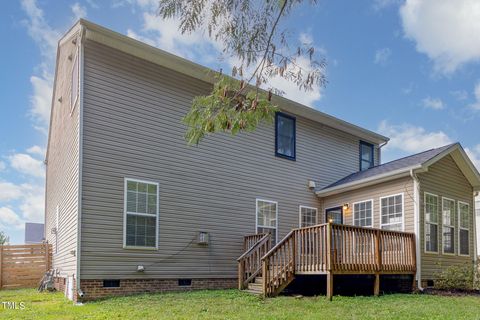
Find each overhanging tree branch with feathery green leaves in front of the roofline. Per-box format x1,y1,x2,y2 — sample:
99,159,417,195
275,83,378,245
158,0,326,144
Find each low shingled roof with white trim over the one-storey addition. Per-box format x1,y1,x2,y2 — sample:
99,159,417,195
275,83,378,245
316,143,480,197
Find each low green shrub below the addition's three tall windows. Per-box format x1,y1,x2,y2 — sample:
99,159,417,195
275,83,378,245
434,263,480,291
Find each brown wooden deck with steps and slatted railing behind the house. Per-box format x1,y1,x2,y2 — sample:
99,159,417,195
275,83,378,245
238,223,416,299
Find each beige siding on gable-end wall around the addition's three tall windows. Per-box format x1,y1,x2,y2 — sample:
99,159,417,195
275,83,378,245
418,156,474,279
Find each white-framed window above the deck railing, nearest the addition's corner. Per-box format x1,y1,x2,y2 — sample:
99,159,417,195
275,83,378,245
380,193,403,231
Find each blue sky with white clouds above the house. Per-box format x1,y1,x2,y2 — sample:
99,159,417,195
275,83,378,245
0,0,480,243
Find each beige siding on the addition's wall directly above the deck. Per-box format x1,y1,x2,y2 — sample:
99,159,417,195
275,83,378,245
319,177,414,232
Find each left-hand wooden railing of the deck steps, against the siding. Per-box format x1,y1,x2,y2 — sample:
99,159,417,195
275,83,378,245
237,234,271,290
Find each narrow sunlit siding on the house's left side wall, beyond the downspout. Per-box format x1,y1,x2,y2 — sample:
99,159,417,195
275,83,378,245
45,35,79,277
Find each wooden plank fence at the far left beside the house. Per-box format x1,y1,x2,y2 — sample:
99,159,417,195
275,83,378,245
0,244,52,289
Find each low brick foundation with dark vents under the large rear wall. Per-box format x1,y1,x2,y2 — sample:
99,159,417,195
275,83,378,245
80,278,237,301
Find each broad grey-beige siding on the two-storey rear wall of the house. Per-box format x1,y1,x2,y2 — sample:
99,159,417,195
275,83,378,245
81,41,376,279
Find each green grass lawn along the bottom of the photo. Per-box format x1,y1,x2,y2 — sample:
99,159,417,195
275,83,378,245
0,289,480,320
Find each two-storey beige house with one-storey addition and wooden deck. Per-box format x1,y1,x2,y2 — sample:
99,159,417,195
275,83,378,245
45,20,480,300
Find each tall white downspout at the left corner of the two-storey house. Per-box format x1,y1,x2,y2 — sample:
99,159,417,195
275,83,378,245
76,25,86,298
